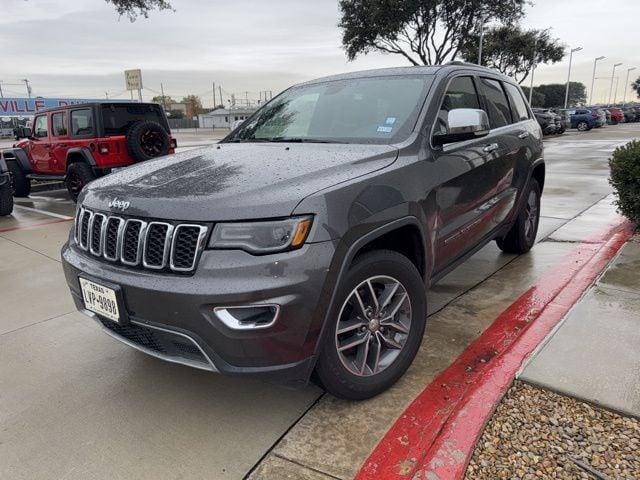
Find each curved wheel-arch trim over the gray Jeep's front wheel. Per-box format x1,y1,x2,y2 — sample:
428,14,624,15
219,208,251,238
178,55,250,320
309,216,429,368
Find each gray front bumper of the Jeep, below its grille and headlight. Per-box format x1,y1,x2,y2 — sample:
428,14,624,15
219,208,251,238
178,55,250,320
62,242,334,383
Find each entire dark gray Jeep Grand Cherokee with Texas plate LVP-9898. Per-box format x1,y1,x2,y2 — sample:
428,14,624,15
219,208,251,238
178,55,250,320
62,63,545,399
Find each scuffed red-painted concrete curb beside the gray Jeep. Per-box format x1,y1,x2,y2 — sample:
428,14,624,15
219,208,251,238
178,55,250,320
355,218,631,480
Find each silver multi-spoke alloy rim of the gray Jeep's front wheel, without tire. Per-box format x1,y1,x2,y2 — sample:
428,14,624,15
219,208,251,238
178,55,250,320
335,275,411,377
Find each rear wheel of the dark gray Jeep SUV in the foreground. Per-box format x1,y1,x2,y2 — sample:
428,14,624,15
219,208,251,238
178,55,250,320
496,178,540,254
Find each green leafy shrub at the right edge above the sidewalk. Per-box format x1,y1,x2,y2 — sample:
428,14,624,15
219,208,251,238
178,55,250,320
609,140,640,225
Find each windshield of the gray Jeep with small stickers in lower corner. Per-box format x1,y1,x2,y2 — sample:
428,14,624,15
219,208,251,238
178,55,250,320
225,75,433,144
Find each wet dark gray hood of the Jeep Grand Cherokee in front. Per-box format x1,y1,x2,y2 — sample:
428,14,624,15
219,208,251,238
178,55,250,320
80,143,398,222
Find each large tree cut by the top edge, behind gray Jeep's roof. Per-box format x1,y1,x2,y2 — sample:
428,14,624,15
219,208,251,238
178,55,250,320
339,0,528,65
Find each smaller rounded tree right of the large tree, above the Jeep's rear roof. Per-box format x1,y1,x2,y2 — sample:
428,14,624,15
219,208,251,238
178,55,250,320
460,25,565,83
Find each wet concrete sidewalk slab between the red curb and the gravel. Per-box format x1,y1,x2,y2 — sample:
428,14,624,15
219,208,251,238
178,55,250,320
519,235,640,418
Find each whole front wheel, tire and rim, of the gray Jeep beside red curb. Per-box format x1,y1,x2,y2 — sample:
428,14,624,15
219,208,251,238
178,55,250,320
316,250,427,400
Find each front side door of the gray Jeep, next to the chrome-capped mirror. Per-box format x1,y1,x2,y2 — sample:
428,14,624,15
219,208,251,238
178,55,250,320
433,74,512,272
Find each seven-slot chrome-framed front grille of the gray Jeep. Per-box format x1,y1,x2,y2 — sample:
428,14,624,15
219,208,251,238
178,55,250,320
74,208,208,272
